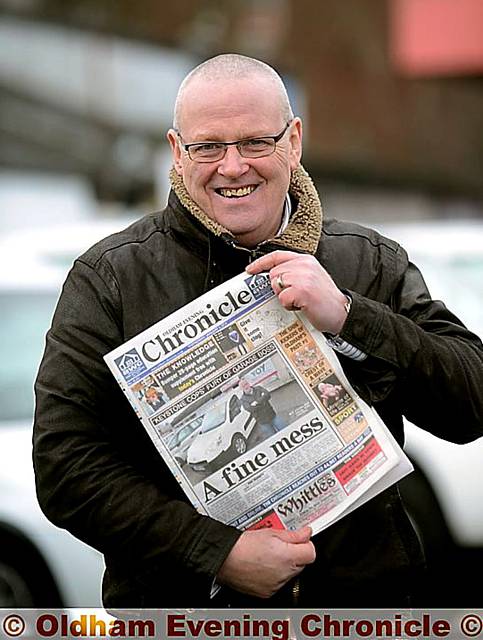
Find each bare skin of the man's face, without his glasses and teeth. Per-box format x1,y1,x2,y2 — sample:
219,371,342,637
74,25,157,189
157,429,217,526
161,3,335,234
168,78,302,247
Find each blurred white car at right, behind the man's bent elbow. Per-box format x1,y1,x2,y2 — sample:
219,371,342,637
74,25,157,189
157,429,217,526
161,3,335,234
375,220,483,606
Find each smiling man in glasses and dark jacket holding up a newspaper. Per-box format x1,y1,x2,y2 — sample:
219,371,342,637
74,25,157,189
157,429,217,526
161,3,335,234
34,54,483,608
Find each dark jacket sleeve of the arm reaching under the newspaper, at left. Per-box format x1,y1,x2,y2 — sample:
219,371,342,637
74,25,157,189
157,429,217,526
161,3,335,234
34,261,240,593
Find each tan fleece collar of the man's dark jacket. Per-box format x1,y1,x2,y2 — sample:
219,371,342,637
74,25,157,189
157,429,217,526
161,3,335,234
169,165,322,253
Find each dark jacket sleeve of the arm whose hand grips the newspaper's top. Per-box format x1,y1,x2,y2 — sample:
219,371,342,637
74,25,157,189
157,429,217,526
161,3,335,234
341,247,483,444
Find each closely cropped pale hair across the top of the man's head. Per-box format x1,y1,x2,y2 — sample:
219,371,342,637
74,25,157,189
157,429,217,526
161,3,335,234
173,53,294,130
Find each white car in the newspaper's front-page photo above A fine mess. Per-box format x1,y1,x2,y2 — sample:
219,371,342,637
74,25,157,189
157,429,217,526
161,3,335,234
187,392,256,471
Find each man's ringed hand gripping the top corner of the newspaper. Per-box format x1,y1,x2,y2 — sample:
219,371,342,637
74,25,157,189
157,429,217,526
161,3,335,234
246,251,347,334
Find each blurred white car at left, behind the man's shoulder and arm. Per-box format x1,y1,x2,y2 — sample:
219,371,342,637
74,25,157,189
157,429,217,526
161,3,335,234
0,215,136,608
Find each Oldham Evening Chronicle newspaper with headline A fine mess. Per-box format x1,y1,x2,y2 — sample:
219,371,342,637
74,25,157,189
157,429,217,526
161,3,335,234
105,273,412,533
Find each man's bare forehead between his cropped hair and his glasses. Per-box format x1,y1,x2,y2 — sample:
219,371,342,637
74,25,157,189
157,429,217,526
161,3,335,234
179,78,284,141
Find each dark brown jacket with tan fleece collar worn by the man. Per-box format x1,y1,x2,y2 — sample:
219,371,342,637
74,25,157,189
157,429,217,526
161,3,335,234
34,171,483,607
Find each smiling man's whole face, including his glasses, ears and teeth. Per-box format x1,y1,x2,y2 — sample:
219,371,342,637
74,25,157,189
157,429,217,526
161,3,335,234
168,61,302,247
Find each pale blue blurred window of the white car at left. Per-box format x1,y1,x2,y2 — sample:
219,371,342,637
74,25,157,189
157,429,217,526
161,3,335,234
0,291,57,421
